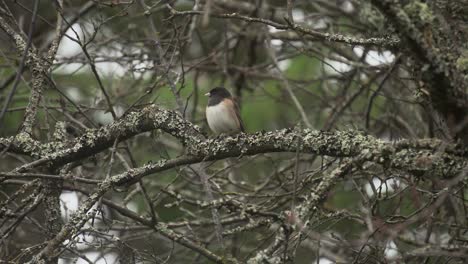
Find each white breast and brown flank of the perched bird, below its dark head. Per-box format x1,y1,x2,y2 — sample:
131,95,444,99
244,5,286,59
206,103,239,134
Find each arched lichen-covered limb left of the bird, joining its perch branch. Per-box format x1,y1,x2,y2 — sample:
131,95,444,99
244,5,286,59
0,105,204,172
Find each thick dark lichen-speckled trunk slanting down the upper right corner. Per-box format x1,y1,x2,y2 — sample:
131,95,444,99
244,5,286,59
371,0,468,142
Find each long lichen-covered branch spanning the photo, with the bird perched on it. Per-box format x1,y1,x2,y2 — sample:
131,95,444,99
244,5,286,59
0,105,468,176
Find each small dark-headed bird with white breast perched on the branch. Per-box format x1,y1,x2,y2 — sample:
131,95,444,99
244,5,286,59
205,87,244,134
